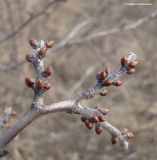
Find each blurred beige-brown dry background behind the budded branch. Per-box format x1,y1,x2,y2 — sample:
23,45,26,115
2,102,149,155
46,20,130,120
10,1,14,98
0,0,157,160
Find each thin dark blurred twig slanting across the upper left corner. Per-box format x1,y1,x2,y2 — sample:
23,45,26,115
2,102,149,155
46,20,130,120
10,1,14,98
0,0,65,43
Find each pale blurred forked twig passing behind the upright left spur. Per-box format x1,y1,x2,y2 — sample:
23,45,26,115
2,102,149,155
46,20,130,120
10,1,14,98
0,9,157,72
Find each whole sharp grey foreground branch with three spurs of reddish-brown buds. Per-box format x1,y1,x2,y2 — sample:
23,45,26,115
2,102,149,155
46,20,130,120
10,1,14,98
0,39,137,157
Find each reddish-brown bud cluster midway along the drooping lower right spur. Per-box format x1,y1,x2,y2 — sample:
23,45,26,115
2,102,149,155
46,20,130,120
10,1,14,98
81,107,109,135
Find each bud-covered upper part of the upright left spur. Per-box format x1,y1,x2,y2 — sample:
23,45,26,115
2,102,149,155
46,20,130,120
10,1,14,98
25,39,54,91
